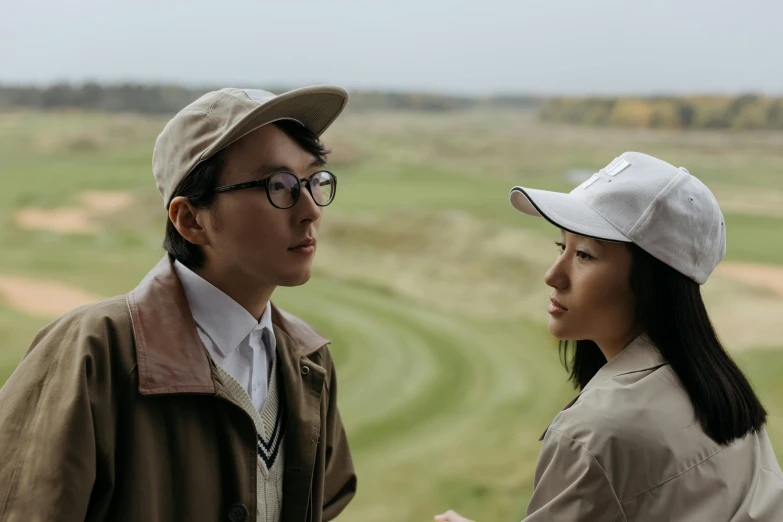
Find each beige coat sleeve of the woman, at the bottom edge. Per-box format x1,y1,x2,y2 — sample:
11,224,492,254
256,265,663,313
525,428,626,522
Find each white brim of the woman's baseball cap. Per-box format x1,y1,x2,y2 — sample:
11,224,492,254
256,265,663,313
509,187,632,243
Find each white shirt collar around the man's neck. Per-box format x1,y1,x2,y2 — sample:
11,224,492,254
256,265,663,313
174,261,275,357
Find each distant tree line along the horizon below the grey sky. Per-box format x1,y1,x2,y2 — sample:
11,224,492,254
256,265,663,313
0,83,783,129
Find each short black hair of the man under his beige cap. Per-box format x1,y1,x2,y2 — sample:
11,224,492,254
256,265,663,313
163,120,329,268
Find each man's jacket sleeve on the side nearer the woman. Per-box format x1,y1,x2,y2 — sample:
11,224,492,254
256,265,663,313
322,346,356,521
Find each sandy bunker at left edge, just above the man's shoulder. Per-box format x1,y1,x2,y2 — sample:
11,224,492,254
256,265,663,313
0,277,101,317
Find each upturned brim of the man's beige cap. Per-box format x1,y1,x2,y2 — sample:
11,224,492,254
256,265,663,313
201,85,348,160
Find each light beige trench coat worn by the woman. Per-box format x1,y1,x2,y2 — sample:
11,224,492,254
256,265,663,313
525,337,783,522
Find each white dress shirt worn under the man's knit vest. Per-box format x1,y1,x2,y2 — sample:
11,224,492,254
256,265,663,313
174,261,276,412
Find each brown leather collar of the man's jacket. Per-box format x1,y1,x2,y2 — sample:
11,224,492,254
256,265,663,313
126,254,329,395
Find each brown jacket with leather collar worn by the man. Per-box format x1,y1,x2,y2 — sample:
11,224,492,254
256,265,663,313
0,256,356,522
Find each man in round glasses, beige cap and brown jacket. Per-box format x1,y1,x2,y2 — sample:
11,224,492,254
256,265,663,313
0,87,356,522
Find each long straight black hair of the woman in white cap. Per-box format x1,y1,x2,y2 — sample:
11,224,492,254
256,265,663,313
560,244,767,445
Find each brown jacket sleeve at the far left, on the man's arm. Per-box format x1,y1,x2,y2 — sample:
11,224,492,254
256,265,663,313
0,304,124,522
